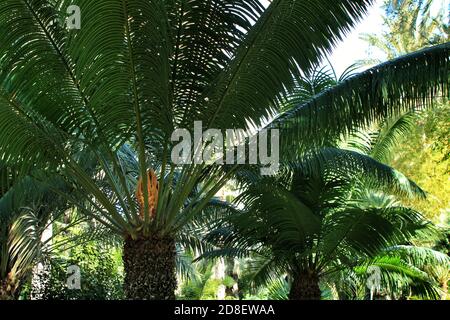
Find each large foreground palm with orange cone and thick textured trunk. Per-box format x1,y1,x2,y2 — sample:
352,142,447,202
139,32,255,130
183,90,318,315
0,0,449,299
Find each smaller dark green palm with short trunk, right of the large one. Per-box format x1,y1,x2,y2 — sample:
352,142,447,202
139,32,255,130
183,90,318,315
202,149,436,300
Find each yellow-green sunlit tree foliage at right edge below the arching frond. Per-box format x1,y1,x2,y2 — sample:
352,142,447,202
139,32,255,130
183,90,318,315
389,104,450,224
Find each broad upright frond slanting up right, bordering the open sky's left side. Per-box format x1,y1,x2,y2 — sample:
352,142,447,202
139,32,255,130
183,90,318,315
201,0,372,128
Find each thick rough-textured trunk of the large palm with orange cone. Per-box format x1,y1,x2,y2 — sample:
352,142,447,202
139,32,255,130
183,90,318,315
123,238,177,300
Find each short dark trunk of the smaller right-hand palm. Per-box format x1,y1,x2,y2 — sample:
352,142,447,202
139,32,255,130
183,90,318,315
289,272,321,300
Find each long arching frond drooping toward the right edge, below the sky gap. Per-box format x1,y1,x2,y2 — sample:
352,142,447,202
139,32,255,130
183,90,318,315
268,43,450,152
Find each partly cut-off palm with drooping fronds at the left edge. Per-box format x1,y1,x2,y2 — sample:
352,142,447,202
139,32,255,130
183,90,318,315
0,163,79,299
